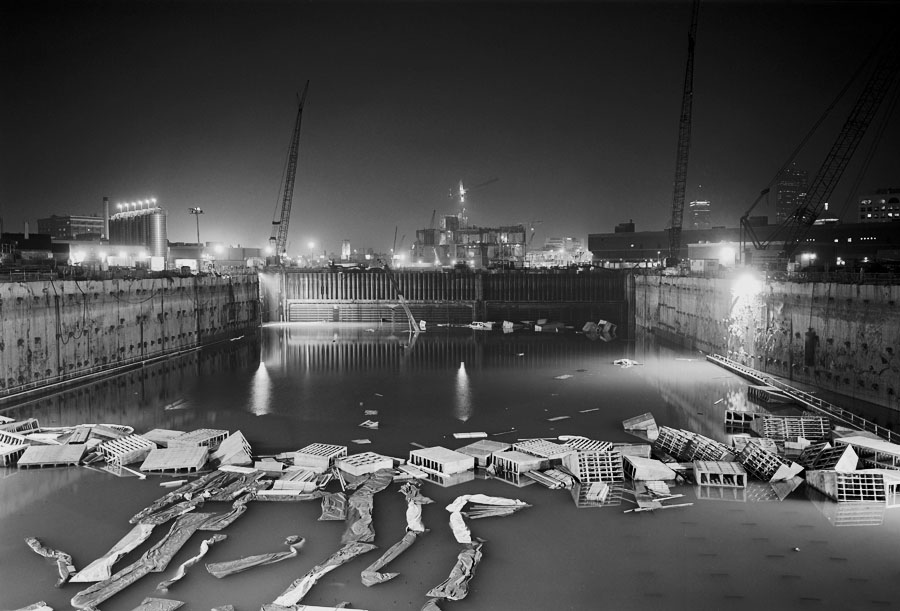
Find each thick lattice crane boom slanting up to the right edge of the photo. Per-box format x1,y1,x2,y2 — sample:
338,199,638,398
741,35,900,263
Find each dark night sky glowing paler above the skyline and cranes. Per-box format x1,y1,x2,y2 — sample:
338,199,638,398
0,0,900,254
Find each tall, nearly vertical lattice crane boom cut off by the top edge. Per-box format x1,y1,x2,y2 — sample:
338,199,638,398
666,0,700,267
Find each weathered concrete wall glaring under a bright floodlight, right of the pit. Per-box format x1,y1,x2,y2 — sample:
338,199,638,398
635,276,900,410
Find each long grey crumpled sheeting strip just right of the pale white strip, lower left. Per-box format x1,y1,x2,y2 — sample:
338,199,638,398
71,513,214,609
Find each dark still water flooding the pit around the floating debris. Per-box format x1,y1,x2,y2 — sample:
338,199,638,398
0,324,900,611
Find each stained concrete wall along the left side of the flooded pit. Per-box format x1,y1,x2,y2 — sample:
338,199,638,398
0,274,259,396
